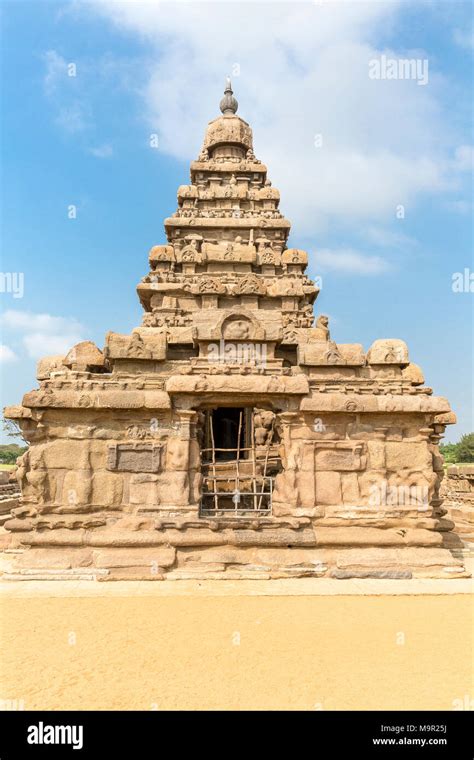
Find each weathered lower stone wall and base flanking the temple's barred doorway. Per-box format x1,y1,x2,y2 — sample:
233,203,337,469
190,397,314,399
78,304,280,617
1,398,464,580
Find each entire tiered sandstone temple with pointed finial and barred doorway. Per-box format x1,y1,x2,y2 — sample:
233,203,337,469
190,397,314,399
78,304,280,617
5,81,465,580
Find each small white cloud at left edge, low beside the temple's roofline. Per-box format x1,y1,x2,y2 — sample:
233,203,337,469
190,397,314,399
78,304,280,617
0,309,84,359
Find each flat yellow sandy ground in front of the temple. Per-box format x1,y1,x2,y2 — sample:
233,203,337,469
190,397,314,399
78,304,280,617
0,579,474,710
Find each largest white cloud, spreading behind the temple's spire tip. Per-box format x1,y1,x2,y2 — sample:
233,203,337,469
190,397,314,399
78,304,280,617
83,0,470,234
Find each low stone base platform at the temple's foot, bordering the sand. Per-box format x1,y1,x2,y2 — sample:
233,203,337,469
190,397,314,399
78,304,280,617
0,546,469,582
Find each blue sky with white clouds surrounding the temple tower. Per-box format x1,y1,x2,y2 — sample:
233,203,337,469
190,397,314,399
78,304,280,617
0,0,474,440
